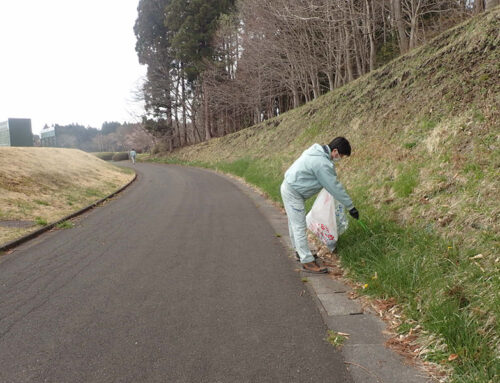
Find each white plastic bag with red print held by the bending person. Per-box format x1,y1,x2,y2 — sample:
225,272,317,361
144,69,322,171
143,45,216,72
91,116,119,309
306,189,348,251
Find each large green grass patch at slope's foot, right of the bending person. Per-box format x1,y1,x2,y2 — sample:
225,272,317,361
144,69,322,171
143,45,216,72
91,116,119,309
338,202,500,382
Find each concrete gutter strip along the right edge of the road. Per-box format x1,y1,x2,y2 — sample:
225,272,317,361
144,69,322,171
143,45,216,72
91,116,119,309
217,173,434,383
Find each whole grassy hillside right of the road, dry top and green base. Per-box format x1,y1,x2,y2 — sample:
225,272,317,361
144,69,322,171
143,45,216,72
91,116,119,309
152,7,500,382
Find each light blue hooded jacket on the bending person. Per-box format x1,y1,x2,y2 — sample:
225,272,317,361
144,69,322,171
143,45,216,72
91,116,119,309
285,144,354,210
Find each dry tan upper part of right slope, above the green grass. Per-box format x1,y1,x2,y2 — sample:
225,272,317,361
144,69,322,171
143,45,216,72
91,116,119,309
174,9,500,251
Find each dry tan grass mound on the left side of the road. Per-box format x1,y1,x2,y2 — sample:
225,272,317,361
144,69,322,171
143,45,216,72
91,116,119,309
0,147,134,244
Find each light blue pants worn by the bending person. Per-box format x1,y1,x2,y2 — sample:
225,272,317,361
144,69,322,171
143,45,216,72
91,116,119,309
281,181,314,263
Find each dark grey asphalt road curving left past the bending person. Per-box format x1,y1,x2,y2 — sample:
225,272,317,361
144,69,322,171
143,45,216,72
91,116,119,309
0,164,351,383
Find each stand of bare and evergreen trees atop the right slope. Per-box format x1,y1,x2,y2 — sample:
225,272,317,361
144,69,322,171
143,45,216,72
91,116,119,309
135,0,499,147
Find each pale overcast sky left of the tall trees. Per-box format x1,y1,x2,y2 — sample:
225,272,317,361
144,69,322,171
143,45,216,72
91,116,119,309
0,0,145,134
